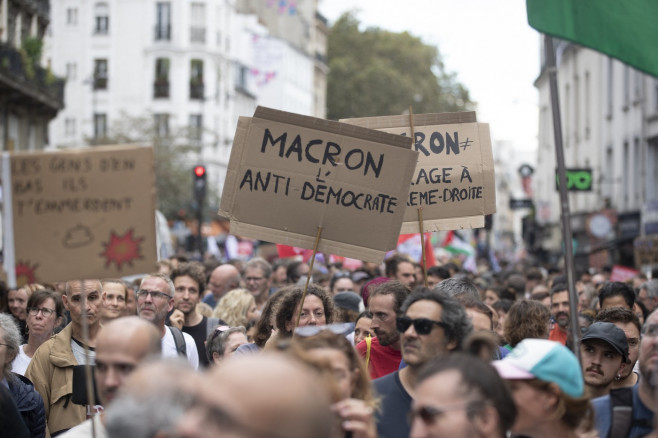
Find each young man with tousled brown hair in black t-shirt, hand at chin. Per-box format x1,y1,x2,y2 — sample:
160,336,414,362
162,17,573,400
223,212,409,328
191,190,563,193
169,262,221,367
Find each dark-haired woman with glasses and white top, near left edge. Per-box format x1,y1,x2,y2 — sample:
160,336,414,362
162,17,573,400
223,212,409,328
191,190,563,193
12,289,64,375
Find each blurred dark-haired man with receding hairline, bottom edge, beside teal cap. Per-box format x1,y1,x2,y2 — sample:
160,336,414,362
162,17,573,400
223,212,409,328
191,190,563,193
409,353,516,438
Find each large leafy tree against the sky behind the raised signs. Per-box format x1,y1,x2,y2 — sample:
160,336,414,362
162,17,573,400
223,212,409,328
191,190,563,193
327,12,475,120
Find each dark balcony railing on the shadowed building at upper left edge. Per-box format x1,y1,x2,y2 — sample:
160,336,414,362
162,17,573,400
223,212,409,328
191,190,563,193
0,44,64,109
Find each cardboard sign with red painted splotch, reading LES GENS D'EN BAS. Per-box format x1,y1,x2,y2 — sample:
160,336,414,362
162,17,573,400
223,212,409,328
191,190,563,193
2,146,157,285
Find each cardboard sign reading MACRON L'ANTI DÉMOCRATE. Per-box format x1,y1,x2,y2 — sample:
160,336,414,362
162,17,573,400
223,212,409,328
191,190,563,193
219,107,418,262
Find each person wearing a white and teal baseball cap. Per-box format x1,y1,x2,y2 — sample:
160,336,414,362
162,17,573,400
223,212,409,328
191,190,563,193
494,339,594,438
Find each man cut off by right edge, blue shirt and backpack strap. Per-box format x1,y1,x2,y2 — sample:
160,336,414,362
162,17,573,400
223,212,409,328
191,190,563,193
592,311,658,438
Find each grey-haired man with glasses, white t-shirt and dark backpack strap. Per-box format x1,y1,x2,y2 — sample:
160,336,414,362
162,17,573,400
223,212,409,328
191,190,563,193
137,274,199,369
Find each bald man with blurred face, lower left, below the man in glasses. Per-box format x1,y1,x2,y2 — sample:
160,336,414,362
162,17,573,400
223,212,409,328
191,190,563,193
61,316,161,438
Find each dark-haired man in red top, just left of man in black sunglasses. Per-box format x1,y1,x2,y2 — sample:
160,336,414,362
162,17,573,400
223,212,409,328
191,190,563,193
356,280,410,379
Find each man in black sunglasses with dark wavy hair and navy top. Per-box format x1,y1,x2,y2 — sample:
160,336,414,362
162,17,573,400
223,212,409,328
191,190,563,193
373,288,473,438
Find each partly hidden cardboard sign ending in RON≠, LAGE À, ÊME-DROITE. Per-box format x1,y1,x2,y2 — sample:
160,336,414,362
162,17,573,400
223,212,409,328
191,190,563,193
341,112,496,233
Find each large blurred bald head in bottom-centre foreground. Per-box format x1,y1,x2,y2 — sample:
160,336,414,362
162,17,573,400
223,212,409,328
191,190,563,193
177,353,333,438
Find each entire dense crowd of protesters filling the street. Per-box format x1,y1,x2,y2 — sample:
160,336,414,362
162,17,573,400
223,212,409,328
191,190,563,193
0,254,658,438
